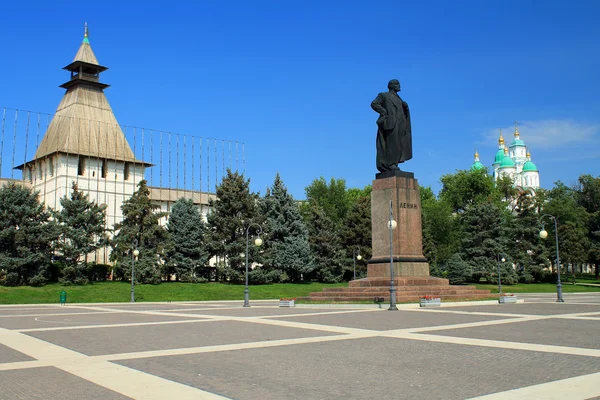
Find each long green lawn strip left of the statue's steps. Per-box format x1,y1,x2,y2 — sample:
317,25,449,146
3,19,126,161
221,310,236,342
0,282,347,304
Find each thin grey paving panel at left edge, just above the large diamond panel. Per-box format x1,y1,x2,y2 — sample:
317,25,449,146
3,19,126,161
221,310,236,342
0,312,198,329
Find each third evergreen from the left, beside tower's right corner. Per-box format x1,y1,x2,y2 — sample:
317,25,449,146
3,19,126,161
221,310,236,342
110,180,168,284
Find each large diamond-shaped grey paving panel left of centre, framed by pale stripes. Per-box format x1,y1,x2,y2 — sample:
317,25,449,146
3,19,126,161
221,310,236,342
27,321,335,356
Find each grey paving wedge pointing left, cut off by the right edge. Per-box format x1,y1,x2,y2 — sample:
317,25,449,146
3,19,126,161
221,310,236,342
423,319,600,350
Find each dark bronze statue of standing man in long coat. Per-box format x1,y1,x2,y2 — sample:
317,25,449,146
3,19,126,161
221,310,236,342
371,79,412,172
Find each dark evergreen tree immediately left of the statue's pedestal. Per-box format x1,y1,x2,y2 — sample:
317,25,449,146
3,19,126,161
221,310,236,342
342,193,372,280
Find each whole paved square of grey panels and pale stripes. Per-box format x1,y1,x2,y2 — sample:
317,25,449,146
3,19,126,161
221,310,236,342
0,293,600,400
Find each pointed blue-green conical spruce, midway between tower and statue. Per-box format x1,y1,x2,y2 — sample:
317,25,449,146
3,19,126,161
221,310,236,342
256,173,313,282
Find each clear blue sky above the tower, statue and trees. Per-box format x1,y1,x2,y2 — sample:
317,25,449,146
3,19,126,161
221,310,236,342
0,0,600,198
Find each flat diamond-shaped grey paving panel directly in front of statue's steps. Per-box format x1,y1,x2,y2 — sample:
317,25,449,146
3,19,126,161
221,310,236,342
272,310,508,331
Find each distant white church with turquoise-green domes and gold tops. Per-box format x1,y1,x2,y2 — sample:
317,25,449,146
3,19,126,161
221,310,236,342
471,124,540,191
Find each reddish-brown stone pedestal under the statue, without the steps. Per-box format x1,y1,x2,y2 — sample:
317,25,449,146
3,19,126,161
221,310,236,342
367,171,429,278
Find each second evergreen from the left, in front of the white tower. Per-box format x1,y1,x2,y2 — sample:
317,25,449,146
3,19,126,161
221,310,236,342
51,182,107,284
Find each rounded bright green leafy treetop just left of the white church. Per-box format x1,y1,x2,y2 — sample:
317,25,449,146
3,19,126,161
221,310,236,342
439,168,494,213
